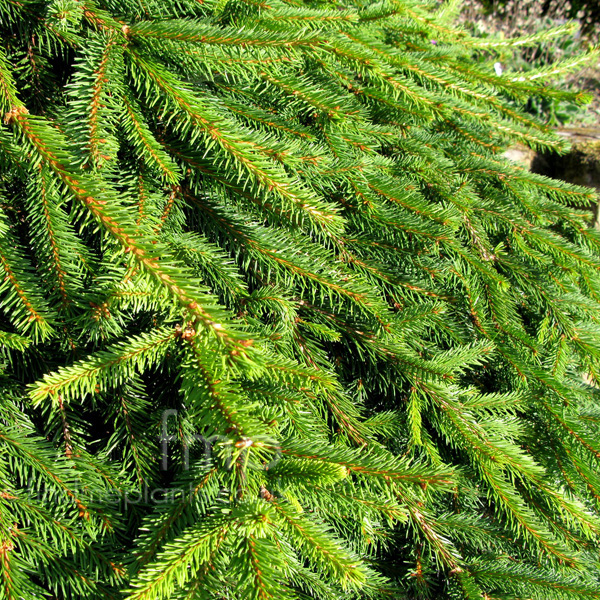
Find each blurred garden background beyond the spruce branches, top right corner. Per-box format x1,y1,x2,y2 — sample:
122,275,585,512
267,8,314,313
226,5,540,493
459,0,600,220
